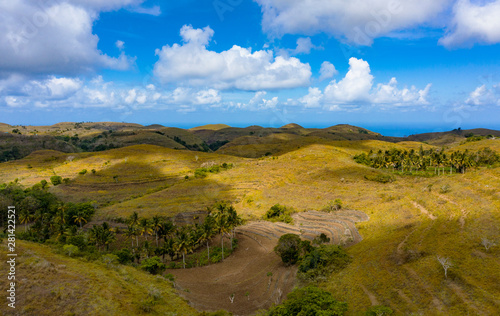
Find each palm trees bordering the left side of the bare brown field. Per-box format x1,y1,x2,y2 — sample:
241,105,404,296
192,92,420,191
123,202,242,268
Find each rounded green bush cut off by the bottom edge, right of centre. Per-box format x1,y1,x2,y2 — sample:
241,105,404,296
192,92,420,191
267,285,347,316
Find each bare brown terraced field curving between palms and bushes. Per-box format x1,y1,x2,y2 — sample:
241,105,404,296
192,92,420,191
167,210,368,315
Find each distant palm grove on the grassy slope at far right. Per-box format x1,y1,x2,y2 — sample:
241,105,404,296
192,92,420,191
354,147,500,175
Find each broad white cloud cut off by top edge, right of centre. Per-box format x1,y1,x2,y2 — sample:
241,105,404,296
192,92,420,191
255,0,452,45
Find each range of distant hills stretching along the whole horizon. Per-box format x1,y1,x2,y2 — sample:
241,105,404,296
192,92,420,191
0,122,500,161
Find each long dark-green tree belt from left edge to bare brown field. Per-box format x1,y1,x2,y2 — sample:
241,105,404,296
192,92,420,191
0,180,242,273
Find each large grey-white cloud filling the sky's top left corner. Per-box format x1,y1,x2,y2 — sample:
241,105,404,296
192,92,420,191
0,0,140,75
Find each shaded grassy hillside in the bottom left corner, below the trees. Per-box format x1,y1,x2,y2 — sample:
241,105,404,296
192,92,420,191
0,240,198,316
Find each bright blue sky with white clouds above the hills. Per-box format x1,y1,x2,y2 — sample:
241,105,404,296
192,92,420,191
0,0,500,136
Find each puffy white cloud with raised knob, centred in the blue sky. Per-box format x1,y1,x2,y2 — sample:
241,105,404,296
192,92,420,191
154,26,311,91
